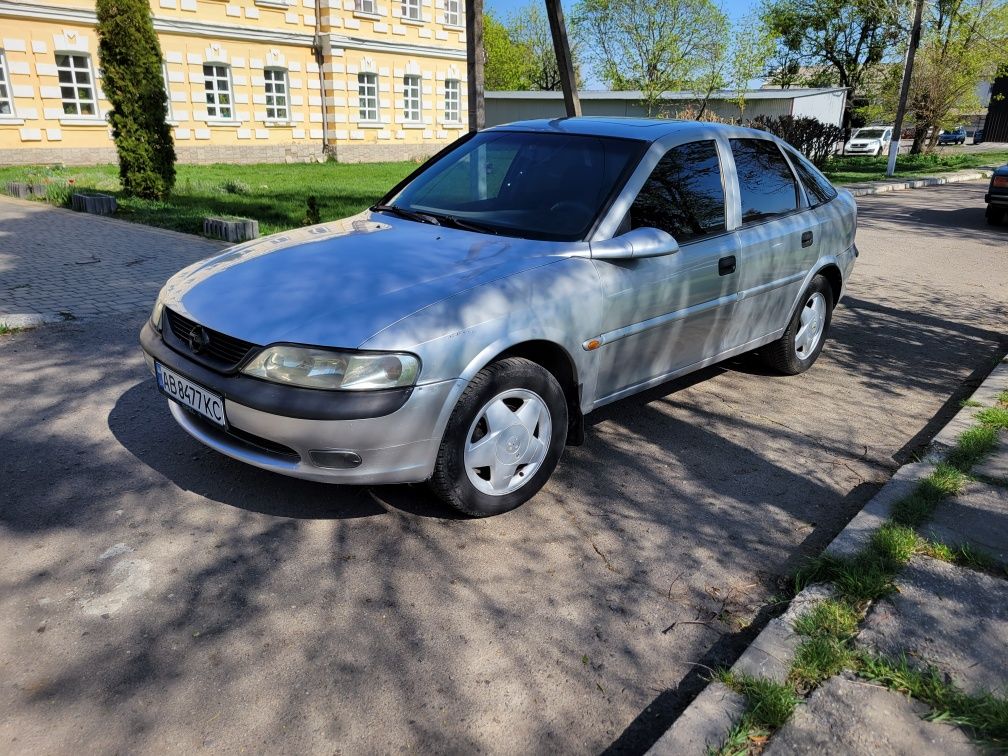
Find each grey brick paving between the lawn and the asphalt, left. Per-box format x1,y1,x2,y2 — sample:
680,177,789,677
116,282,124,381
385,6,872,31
0,197,225,325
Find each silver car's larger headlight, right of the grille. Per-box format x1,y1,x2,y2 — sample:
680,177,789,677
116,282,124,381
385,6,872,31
242,346,420,391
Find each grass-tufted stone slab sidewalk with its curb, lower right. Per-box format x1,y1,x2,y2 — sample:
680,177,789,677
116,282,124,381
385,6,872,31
649,360,1008,756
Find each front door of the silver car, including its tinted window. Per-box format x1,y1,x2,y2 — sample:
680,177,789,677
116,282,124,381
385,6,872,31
594,139,738,401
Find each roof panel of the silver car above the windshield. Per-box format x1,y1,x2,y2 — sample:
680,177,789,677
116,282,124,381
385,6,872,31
487,116,773,142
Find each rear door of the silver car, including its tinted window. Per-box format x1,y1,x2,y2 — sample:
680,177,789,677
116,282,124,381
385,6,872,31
727,138,818,347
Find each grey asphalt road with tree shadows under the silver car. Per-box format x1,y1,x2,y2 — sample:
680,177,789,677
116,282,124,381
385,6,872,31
0,182,1008,753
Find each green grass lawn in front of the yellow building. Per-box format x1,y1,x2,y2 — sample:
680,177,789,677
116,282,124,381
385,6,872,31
0,162,416,236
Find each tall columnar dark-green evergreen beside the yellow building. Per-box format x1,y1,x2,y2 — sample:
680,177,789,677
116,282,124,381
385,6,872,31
96,0,175,199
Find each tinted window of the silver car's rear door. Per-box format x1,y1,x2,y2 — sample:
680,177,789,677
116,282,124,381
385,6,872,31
731,139,798,226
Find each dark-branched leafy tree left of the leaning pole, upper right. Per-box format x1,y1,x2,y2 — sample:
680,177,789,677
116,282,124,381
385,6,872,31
761,0,906,127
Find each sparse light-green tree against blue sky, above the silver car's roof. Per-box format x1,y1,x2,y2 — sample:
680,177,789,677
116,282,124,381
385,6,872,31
575,0,729,113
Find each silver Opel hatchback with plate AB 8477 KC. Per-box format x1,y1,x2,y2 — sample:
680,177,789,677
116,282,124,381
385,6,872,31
140,118,857,516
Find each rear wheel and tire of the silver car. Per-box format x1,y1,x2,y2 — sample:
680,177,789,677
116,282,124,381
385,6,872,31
760,275,834,375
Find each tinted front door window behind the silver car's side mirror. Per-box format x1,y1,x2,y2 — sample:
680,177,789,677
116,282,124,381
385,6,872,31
630,140,725,244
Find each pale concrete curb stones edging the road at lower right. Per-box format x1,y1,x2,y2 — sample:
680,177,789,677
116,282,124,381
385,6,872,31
647,359,1008,756
